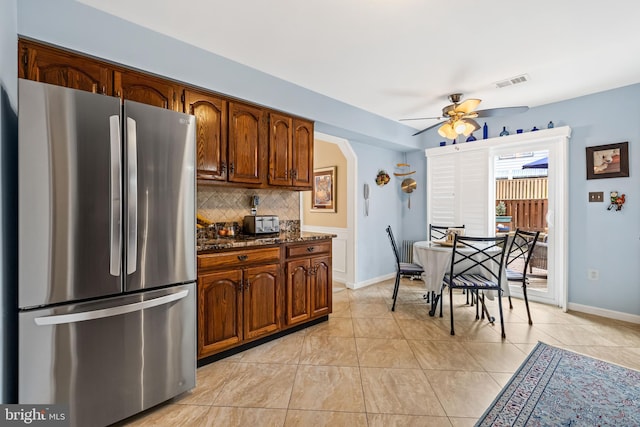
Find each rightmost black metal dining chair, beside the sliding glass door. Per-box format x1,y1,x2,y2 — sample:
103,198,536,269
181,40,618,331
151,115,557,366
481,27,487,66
506,228,540,325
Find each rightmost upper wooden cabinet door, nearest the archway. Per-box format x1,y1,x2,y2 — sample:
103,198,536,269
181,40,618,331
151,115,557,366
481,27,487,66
292,119,313,190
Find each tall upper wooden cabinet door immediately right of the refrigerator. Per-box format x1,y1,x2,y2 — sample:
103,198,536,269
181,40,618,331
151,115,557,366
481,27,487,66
185,90,227,181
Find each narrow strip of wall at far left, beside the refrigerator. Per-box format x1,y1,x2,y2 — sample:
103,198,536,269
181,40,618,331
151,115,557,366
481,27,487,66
0,0,18,403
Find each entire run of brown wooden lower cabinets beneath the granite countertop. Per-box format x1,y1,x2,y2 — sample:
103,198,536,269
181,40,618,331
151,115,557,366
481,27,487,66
198,239,332,359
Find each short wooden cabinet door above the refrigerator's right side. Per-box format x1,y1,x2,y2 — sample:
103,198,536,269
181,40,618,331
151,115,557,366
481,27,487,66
113,70,183,111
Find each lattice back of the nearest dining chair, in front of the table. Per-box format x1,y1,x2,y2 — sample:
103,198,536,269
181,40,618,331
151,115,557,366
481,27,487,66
449,234,507,289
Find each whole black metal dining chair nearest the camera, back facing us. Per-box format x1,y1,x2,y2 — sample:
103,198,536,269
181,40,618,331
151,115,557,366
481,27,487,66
440,235,507,339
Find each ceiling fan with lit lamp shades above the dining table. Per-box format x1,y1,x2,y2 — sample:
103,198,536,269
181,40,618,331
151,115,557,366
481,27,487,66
400,93,529,139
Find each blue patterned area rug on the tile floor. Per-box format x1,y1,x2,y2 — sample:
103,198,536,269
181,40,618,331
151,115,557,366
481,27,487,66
476,342,640,427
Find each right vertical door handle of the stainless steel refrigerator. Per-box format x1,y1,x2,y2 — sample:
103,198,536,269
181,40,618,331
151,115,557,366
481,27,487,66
127,117,138,274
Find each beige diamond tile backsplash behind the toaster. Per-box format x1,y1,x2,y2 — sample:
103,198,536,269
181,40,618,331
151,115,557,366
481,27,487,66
198,185,300,224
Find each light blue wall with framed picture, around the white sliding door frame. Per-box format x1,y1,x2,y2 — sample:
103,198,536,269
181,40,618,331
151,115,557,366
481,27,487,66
423,84,640,315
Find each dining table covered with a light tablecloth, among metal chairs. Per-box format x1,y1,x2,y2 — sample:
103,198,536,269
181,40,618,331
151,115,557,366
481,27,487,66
413,240,510,316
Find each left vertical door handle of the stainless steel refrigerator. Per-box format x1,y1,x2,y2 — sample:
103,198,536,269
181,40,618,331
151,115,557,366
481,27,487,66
109,115,122,276
